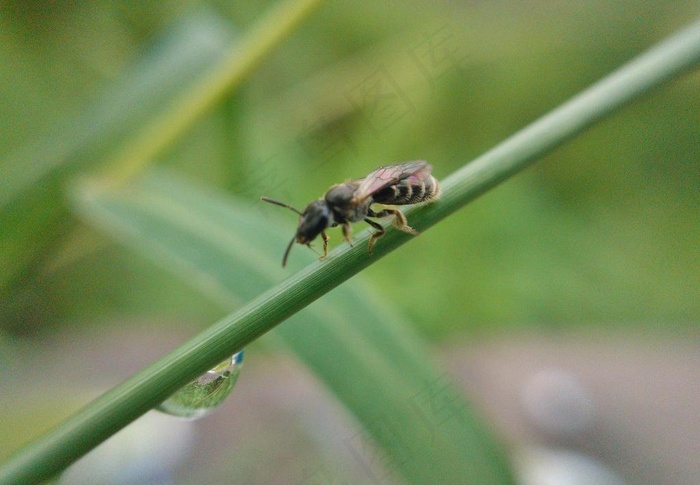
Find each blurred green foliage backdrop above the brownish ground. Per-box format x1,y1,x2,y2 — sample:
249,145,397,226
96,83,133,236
0,1,700,482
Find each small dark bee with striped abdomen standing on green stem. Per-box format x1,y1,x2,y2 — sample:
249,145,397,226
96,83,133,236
261,160,440,267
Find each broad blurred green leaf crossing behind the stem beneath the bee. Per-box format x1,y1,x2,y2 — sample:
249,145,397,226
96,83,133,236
72,174,507,483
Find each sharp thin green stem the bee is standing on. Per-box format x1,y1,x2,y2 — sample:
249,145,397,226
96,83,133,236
0,18,700,483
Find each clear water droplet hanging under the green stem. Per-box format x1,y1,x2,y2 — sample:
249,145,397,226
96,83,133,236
156,350,243,419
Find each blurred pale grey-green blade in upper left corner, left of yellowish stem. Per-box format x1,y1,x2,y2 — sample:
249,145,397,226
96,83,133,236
0,11,234,206
